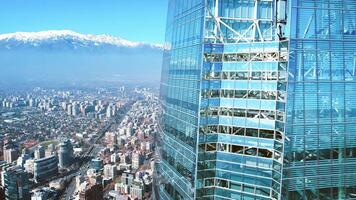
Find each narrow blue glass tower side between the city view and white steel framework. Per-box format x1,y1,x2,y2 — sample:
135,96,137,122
157,0,204,199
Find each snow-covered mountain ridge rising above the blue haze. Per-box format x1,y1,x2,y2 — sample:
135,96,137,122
0,30,162,50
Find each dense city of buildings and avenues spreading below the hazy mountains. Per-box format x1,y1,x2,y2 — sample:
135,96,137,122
0,86,161,200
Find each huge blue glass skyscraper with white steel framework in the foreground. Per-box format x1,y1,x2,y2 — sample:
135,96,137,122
156,0,356,200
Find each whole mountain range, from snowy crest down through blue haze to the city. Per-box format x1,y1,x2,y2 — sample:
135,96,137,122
0,30,163,84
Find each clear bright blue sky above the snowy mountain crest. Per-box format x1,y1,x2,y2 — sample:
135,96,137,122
0,0,168,43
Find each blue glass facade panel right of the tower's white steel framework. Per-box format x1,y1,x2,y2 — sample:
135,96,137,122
283,0,356,199
